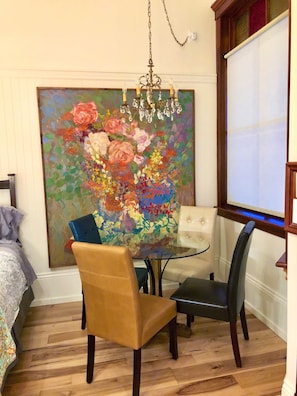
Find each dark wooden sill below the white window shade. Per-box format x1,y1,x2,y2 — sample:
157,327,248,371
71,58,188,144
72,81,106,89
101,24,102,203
218,207,286,238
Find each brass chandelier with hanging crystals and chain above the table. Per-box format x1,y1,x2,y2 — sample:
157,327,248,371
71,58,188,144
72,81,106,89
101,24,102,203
120,0,182,123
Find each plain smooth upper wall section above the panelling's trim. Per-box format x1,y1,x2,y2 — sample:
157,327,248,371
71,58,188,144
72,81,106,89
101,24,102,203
0,0,215,76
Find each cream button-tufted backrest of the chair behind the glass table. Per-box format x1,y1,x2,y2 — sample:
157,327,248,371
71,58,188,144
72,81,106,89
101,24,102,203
178,205,217,263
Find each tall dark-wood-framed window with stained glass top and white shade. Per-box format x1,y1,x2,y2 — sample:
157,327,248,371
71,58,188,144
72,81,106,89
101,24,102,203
212,0,288,237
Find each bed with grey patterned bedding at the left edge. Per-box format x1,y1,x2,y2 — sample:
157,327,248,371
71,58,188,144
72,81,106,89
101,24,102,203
0,174,36,394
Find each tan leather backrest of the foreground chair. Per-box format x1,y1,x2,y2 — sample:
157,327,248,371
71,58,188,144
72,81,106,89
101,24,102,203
72,242,142,349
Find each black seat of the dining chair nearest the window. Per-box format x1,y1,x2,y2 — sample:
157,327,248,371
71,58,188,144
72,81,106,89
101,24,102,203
170,278,229,321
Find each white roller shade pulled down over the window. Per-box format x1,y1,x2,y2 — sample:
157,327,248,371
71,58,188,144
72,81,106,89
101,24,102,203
226,16,288,217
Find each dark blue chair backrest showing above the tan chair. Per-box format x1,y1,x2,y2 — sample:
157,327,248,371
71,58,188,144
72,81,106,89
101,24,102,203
69,214,101,243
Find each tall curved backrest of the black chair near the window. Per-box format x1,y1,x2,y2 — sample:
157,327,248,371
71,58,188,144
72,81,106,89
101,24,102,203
228,221,255,320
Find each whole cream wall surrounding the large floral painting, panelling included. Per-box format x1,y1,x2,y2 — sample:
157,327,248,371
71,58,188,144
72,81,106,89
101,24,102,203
0,0,216,304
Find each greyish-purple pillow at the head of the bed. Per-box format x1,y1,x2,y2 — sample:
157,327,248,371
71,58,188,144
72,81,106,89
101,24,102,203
0,206,24,242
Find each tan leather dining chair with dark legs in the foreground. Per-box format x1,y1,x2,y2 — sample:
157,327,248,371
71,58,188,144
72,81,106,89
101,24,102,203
72,242,178,396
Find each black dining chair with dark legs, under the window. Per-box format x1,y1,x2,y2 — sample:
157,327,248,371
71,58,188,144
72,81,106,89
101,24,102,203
170,221,255,367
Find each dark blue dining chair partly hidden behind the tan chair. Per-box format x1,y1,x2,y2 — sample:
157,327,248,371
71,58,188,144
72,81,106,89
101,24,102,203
69,213,148,329
